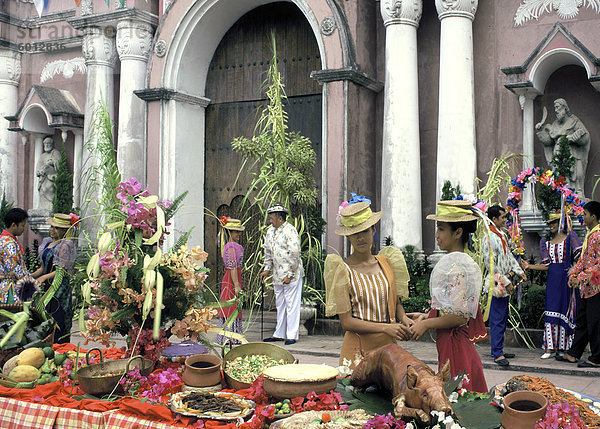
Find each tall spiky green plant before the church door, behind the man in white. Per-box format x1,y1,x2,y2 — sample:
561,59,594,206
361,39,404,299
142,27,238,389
232,34,324,310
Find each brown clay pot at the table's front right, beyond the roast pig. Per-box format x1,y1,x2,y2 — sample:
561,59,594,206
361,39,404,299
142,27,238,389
500,390,548,429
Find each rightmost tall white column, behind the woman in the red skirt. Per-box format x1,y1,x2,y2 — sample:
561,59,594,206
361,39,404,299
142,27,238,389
435,0,478,199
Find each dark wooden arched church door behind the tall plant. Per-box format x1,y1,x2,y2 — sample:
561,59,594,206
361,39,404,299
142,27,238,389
204,2,322,284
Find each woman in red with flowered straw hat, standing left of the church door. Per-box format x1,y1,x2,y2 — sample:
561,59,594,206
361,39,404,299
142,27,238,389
217,216,246,344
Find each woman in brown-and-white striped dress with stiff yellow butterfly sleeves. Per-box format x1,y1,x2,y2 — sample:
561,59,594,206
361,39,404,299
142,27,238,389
324,194,412,368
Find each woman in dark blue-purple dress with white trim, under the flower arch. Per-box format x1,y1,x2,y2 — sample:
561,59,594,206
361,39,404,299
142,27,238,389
522,213,581,359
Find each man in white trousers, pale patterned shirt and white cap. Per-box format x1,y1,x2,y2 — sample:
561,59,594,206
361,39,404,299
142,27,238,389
260,204,304,345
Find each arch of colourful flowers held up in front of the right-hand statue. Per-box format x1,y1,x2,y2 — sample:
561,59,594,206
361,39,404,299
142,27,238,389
506,167,584,256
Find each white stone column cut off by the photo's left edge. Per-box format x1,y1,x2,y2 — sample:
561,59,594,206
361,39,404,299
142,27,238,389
0,48,21,203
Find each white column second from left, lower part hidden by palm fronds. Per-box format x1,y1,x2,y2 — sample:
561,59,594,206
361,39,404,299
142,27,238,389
81,27,117,226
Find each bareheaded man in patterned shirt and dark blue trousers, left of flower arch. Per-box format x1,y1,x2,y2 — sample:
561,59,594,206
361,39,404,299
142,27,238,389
481,205,527,366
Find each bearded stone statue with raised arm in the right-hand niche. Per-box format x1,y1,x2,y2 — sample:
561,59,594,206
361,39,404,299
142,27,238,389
535,98,590,198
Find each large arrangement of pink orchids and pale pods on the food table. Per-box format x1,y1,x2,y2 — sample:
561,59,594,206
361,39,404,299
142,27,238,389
79,178,216,360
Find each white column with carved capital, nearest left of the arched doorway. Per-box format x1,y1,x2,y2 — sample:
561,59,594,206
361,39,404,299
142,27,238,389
117,19,152,183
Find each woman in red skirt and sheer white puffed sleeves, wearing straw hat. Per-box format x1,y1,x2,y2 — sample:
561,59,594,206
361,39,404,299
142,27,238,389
409,201,488,393
